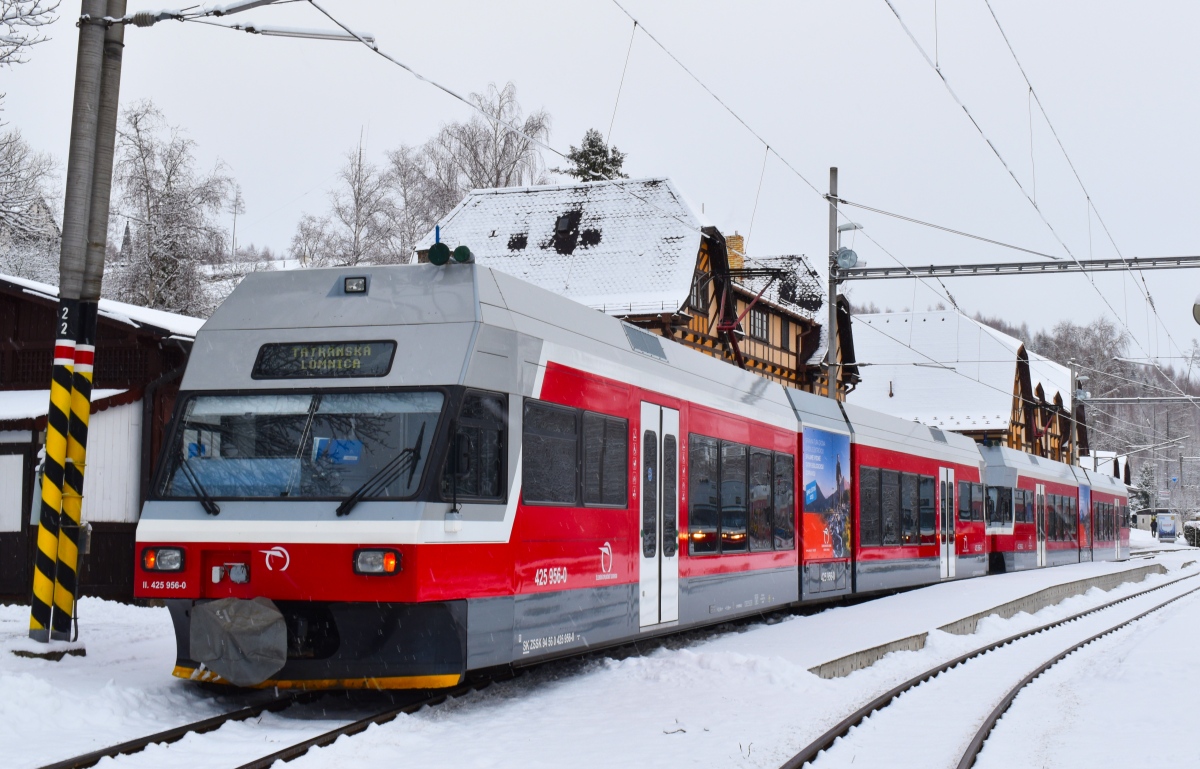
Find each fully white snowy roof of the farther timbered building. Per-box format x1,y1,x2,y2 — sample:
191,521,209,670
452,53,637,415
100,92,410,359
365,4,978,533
848,310,1070,431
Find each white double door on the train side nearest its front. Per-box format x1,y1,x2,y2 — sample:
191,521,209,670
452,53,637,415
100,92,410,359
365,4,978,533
638,403,679,627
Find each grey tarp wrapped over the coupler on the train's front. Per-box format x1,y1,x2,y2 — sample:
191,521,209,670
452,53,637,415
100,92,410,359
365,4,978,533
191,597,288,686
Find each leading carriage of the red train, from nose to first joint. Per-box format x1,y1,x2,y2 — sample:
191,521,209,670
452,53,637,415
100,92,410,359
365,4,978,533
137,265,799,687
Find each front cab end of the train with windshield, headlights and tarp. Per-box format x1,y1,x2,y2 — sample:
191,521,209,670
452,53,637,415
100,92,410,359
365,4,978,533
136,265,511,689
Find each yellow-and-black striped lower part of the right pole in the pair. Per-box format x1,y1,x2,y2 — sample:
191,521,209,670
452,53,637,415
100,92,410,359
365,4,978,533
50,301,97,641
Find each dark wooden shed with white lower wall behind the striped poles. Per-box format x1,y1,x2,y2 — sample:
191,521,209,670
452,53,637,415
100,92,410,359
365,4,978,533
0,276,203,602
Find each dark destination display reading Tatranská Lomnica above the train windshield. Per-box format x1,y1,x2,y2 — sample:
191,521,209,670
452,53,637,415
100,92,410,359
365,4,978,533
251,341,396,379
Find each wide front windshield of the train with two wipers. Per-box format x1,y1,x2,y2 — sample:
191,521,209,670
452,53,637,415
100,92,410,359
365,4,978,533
160,392,444,499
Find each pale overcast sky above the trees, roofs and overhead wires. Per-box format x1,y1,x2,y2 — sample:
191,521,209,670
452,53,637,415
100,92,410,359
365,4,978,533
9,0,1200,358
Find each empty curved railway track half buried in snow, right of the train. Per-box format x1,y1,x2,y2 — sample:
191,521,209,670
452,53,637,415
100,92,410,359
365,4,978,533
782,573,1200,769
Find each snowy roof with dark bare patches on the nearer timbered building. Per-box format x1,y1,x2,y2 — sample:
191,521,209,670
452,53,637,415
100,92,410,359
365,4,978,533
416,179,708,316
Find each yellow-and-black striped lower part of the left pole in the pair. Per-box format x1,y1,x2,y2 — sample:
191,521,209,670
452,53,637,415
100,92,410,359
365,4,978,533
29,299,79,642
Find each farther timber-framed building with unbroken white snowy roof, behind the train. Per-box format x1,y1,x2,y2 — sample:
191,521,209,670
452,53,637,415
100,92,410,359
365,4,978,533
850,310,1087,462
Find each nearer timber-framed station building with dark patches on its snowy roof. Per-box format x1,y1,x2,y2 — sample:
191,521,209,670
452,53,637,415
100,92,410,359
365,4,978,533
416,178,857,391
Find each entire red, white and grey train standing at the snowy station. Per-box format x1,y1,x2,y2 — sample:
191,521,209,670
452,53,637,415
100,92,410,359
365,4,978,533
136,263,1129,687
